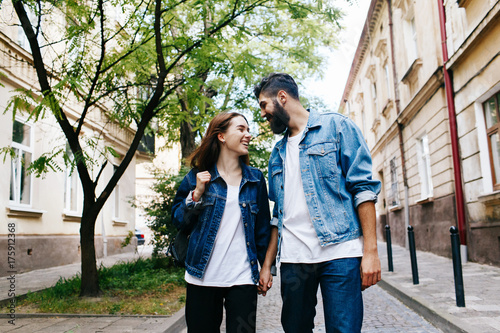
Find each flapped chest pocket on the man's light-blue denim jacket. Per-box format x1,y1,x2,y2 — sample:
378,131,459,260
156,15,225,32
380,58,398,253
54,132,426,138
305,142,338,178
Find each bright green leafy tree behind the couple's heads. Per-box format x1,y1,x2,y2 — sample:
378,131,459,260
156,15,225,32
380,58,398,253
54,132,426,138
161,3,341,158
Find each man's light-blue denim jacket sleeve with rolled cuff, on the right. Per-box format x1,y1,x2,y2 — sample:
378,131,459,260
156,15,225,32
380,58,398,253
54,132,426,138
338,118,381,207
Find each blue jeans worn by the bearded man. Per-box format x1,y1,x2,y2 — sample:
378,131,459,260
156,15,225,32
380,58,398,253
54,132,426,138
281,258,363,333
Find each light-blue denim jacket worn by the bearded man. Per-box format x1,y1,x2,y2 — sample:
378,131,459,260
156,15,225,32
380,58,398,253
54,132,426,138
269,111,381,256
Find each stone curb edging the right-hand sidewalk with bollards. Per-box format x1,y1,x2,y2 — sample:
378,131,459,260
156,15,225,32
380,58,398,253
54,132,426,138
377,279,481,333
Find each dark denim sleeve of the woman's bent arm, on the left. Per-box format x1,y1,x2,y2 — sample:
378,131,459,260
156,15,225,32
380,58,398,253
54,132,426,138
172,170,202,230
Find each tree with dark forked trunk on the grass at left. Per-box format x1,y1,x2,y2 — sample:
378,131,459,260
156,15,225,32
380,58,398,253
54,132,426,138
5,0,346,296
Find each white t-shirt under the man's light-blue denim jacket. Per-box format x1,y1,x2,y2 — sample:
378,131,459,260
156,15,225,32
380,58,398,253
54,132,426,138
281,131,363,264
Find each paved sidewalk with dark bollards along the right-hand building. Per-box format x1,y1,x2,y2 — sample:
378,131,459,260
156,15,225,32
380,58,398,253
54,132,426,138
378,243,500,333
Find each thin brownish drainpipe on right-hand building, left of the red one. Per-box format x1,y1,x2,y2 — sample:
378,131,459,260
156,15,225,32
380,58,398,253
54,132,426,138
387,0,410,249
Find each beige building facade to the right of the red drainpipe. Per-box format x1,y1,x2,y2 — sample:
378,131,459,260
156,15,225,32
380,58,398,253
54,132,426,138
445,0,500,265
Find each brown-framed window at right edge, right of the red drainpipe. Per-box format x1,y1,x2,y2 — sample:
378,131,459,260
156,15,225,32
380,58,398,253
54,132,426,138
483,93,500,190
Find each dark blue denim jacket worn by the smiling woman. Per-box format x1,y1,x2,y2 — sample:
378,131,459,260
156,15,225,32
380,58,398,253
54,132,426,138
172,163,271,283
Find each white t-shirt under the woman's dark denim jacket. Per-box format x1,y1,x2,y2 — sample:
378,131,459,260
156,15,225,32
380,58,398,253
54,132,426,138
185,185,254,287
